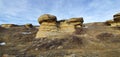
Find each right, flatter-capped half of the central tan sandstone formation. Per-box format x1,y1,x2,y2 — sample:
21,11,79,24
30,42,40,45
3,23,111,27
60,17,84,33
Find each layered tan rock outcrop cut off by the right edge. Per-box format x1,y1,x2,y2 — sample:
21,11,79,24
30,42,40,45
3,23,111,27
105,13,120,27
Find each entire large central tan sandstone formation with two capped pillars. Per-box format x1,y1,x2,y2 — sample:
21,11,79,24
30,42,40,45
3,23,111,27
36,14,84,38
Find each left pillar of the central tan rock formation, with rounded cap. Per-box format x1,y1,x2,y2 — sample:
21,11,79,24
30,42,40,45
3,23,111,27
36,14,57,38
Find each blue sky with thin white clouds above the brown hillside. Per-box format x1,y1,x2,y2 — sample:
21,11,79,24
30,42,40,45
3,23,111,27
0,0,120,25
